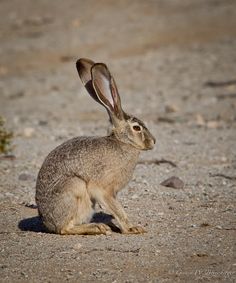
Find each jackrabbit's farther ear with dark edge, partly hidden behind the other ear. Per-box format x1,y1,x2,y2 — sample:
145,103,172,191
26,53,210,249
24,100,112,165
76,58,101,103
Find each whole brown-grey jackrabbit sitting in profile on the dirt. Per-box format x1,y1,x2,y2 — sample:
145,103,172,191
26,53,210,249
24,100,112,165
36,59,155,235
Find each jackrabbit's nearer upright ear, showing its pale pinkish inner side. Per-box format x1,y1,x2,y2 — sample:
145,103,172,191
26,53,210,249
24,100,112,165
91,63,124,120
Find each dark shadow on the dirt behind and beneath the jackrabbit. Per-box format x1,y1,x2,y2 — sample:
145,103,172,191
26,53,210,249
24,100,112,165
18,212,120,233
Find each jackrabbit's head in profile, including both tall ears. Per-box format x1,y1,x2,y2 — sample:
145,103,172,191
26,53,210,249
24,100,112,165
76,58,155,150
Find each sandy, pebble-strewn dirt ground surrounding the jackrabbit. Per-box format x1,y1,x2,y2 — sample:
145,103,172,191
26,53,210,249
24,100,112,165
0,0,236,283
